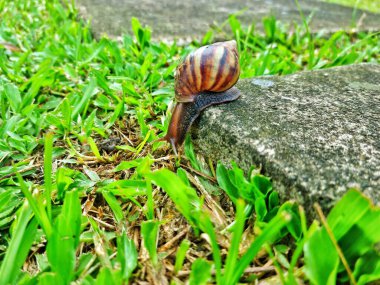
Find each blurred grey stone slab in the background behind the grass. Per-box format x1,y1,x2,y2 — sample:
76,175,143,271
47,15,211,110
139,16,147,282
76,0,380,42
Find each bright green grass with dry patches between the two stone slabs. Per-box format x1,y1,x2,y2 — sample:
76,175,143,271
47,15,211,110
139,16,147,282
0,0,380,284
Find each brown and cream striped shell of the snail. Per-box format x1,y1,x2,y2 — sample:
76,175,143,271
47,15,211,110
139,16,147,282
175,40,240,102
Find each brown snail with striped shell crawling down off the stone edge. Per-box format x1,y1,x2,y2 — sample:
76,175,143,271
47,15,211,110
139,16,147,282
161,40,240,155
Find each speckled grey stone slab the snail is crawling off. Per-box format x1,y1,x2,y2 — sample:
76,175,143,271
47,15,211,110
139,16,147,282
192,64,380,213
